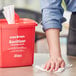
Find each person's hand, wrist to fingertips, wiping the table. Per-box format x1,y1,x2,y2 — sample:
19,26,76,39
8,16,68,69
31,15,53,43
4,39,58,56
44,56,65,72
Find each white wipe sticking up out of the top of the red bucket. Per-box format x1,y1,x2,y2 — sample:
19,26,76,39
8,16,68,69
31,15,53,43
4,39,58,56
3,5,15,24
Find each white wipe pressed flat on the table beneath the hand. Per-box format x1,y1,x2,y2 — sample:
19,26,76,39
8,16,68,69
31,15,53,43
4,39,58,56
35,64,72,72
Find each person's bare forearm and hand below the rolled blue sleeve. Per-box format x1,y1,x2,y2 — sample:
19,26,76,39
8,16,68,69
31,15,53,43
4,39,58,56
44,29,65,72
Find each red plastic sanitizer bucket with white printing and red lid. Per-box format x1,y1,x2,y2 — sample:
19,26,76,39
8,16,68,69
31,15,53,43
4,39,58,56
0,18,37,67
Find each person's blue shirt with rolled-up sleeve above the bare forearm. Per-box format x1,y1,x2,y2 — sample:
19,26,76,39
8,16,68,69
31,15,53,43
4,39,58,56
41,0,76,30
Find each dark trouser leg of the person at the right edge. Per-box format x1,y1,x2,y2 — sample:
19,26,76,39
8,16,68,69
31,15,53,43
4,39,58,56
67,13,76,56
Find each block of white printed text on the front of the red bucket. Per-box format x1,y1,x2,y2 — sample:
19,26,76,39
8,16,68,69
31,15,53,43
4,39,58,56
8,35,26,54
